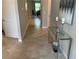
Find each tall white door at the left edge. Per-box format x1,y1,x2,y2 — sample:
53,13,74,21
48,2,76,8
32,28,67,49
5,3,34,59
2,0,19,38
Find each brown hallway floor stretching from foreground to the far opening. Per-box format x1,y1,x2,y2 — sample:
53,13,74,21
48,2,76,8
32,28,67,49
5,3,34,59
3,26,56,59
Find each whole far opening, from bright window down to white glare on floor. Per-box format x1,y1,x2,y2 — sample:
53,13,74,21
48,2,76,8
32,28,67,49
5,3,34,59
32,0,42,28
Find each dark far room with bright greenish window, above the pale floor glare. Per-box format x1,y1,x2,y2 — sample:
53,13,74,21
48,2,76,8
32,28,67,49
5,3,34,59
32,0,41,16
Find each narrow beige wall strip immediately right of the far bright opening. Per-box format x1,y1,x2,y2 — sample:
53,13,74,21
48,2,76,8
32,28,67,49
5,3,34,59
41,0,48,27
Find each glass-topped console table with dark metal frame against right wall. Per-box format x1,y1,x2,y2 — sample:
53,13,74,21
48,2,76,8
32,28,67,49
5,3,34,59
48,27,72,59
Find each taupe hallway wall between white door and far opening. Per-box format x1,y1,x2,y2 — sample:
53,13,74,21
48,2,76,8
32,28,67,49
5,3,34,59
17,0,32,37
